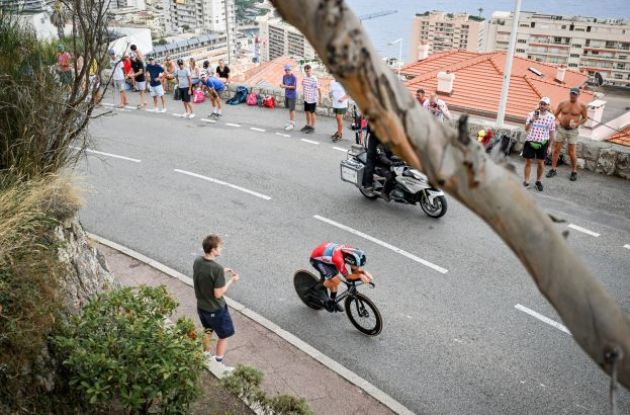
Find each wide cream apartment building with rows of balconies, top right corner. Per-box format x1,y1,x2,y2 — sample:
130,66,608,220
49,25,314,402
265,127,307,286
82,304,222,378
485,12,630,86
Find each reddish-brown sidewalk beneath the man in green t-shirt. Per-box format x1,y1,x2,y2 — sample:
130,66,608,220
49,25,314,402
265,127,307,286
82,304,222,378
96,237,404,415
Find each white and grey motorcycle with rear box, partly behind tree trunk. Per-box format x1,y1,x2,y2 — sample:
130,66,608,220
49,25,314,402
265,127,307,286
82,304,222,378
340,145,448,219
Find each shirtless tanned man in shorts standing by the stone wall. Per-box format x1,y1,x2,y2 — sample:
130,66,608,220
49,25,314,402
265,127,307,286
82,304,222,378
547,88,588,182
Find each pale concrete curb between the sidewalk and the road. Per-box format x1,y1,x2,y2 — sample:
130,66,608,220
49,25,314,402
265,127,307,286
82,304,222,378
87,232,414,415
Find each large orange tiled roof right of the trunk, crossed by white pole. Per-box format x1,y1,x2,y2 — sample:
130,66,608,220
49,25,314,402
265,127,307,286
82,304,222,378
408,51,593,121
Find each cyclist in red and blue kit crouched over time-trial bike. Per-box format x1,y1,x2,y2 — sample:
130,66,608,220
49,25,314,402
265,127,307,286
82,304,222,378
310,242,373,312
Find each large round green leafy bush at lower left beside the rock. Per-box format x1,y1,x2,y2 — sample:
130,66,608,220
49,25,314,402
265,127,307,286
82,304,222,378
55,286,203,414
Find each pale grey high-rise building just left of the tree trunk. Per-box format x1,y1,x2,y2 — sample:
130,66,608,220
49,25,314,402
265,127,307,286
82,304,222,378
257,14,315,62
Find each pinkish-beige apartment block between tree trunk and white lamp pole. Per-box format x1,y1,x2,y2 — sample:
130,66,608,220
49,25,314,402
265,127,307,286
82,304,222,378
409,11,487,62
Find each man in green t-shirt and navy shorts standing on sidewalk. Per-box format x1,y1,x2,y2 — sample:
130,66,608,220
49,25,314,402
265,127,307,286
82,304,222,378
193,235,240,369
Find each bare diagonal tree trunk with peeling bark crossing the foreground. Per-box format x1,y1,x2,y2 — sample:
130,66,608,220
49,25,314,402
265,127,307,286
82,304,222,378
272,0,630,389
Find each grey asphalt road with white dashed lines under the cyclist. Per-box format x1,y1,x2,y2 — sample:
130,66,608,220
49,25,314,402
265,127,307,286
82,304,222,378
77,98,630,414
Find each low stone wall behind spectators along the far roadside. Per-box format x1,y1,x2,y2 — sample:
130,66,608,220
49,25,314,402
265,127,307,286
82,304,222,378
224,85,630,179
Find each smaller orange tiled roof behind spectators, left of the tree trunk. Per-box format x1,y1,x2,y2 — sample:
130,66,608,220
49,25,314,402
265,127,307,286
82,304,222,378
233,56,333,96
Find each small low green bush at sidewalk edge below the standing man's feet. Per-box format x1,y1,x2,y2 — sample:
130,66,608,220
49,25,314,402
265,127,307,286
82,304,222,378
221,365,313,415
